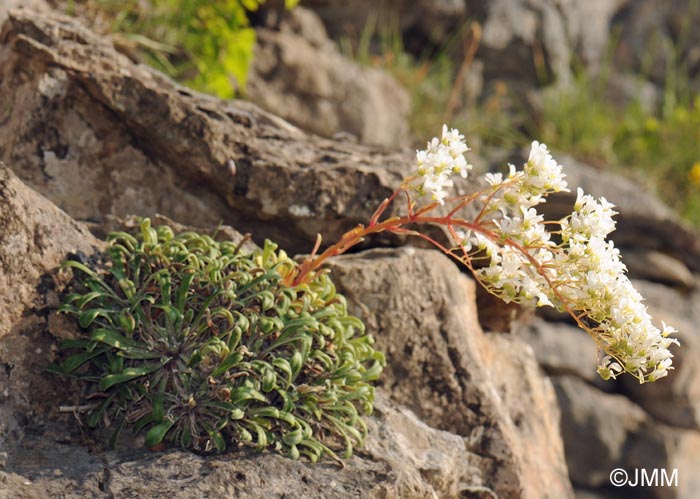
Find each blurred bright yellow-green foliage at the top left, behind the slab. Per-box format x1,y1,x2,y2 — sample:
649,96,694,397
74,0,299,99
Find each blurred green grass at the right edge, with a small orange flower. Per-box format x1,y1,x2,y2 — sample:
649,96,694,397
530,74,700,227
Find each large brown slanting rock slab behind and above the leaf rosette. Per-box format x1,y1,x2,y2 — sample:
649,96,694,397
0,11,411,252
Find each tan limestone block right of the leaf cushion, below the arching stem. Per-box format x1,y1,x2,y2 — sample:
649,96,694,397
330,248,572,497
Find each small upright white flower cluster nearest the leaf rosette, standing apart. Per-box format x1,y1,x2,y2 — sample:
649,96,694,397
416,125,472,204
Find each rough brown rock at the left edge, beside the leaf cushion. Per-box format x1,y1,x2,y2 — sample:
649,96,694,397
0,163,102,462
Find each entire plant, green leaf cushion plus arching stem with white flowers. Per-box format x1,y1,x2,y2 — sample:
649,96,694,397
54,126,678,461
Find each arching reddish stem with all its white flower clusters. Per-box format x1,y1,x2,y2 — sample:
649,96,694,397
286,126,678,383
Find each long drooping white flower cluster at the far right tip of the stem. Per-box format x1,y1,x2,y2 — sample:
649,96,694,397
555,189,679,382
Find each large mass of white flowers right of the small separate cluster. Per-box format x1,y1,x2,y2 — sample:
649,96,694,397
448,142,678,382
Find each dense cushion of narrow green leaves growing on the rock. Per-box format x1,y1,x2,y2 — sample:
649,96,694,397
51,219,385,462
